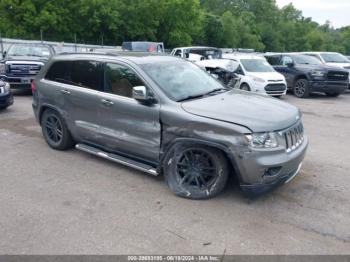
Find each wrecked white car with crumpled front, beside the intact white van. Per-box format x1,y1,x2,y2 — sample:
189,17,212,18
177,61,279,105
195,59,241,88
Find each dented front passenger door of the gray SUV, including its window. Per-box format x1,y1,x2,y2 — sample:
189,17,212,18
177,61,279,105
100,62,161,162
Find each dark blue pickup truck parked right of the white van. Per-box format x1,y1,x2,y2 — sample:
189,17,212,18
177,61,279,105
265,53,349,98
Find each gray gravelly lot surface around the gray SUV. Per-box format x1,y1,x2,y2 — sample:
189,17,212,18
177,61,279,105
0,93,350,254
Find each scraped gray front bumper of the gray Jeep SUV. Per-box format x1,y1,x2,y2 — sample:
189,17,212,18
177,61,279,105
237,136,309,196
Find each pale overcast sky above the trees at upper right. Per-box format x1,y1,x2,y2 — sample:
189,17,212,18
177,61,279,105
276,0,350,28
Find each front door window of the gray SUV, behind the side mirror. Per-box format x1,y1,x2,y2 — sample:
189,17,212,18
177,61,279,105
105,63,145,98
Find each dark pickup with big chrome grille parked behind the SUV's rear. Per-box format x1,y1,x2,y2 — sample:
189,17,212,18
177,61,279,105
0,44,55,90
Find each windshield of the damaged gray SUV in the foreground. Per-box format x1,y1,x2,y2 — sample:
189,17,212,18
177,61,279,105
141,60,225,101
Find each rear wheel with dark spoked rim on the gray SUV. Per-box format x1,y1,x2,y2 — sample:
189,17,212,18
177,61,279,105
41,109,74,150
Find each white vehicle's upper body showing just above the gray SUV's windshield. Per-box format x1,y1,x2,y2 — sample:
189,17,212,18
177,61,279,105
170,46,222,62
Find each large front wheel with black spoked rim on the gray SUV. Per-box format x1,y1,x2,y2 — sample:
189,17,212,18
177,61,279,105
164,145,229,199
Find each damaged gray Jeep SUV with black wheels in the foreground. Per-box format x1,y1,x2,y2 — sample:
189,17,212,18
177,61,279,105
32,52,308,199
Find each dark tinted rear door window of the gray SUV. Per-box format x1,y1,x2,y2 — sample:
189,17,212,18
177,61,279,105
70,60,103,91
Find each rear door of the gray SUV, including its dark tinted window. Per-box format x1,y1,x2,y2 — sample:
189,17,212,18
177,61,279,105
60,60,103,144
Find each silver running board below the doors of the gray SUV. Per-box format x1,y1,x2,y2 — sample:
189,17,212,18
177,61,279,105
75,144,159,176
